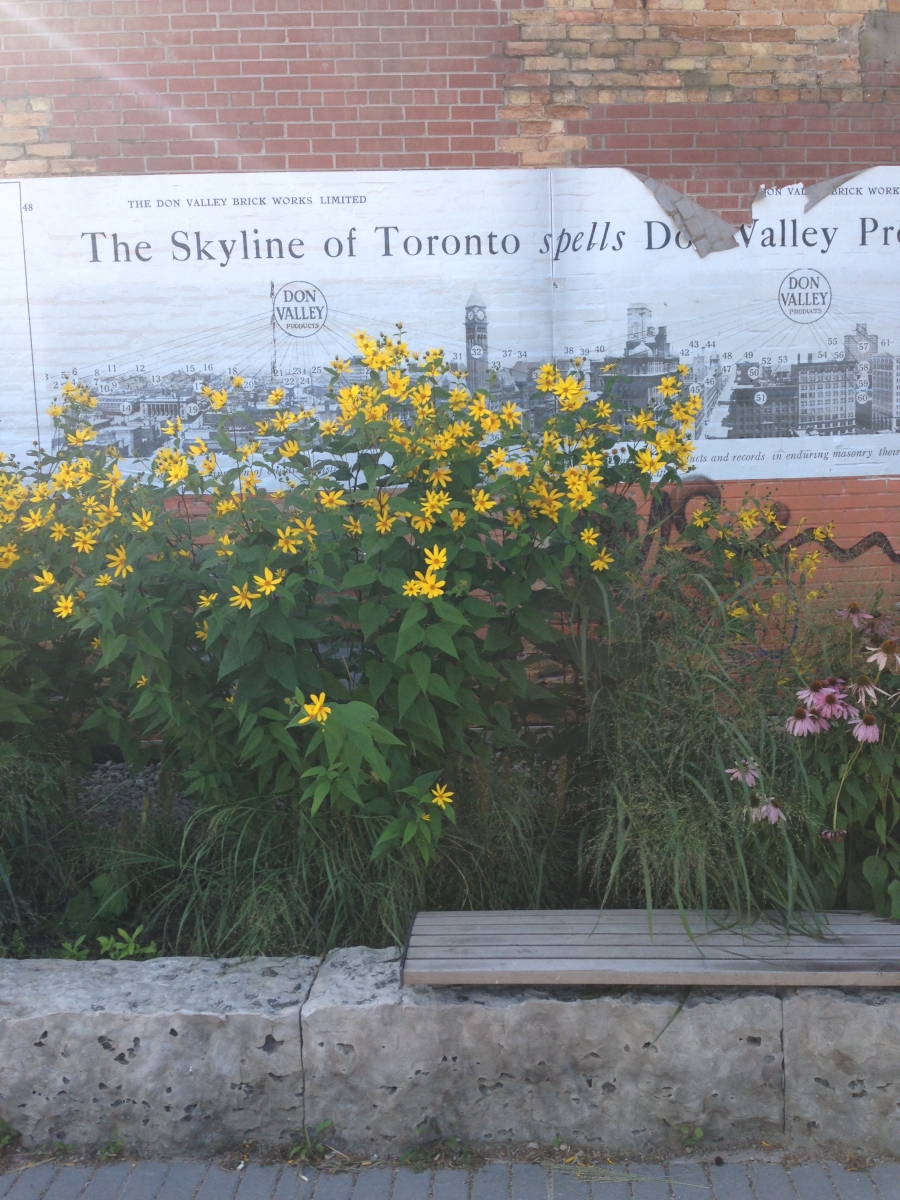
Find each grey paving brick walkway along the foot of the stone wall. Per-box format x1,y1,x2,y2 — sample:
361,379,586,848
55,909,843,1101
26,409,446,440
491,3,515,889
0,1163,900,1200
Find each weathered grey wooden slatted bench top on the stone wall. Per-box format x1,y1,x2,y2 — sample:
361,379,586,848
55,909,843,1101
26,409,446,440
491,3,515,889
401,908,900,988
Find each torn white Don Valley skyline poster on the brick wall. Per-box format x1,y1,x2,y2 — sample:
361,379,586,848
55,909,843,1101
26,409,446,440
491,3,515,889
0,167,900,480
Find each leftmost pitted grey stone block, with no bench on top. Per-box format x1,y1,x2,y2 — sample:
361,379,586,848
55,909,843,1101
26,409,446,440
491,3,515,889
0,959,318,1152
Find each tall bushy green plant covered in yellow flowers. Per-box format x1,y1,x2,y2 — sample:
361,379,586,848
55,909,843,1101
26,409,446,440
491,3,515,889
0,334,700,859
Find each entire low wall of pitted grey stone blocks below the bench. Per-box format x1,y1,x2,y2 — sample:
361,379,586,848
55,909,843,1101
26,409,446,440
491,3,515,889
0,947,900,1154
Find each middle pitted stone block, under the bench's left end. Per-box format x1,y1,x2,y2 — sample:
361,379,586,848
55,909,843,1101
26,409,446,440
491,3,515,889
302,948,784,1153
